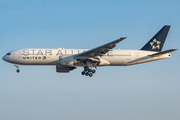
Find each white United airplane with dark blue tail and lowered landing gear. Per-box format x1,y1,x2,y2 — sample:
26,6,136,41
2,25,177,77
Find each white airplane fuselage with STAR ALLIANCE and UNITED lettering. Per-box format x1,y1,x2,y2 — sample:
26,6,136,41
4,48,171,67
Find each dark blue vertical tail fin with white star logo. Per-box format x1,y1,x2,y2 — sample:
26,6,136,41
141,25,170,52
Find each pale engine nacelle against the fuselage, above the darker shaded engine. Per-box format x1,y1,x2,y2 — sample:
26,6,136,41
59,56,77,67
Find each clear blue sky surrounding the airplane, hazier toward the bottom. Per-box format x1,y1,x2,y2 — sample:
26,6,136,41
0,0,180,120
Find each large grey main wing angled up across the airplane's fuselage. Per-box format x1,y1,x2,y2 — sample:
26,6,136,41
75,37,126,59
